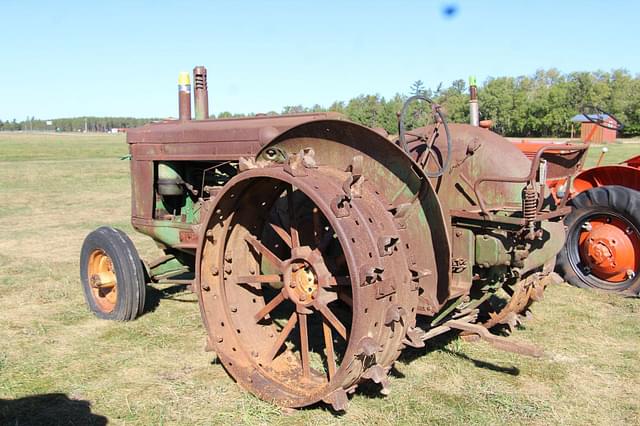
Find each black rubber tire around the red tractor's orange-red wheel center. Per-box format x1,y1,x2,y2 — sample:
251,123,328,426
556,185,640,296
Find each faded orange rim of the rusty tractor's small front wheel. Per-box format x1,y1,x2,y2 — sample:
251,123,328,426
87,250,118,313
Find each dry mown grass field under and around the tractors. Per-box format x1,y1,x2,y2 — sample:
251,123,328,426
0,133,640,425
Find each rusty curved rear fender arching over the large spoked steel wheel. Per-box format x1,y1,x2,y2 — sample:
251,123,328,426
256,120,451,314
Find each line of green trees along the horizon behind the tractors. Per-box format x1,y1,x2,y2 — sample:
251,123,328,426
0,69,640,137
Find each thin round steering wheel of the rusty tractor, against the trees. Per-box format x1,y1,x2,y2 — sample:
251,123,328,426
398,95,452,178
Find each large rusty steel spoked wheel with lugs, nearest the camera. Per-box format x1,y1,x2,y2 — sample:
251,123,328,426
199,163,417,410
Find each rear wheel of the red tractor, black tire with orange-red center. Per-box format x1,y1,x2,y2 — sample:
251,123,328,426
557,185,640,295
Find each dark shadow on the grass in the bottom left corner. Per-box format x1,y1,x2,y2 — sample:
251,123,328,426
0,393,108,426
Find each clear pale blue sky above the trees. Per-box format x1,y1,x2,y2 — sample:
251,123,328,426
0,0,640,120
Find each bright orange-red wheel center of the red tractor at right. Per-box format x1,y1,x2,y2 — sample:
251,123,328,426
579,217,640,282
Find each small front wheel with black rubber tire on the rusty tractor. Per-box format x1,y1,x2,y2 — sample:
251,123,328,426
80,226,146,321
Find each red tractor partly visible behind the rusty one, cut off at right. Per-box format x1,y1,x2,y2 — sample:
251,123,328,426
516,106,640,296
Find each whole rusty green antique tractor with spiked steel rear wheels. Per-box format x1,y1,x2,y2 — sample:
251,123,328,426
81,67,585,410
